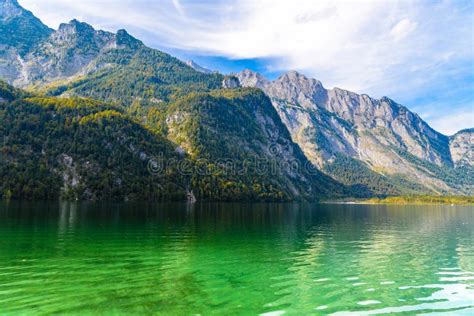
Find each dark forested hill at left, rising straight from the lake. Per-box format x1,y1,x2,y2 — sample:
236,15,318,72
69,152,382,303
0,93,187,200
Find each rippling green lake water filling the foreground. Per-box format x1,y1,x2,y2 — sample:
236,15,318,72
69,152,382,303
0,202,474,315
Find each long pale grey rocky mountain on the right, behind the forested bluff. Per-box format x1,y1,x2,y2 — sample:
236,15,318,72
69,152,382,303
237,70,474,194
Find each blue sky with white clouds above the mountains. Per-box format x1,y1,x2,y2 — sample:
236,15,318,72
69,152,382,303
19,0,474,135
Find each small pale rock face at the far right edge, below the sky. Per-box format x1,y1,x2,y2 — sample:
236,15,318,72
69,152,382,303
449,128,474,167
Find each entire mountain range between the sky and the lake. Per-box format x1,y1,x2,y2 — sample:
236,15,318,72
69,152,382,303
0,0,474,201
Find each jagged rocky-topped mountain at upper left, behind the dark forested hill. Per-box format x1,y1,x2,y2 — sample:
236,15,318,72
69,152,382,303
0,8,222,106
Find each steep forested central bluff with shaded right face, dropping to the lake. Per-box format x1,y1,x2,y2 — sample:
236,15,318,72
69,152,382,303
148,89,348,200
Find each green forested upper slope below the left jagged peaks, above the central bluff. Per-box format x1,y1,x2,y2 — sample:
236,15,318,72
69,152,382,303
47,46,222,107
